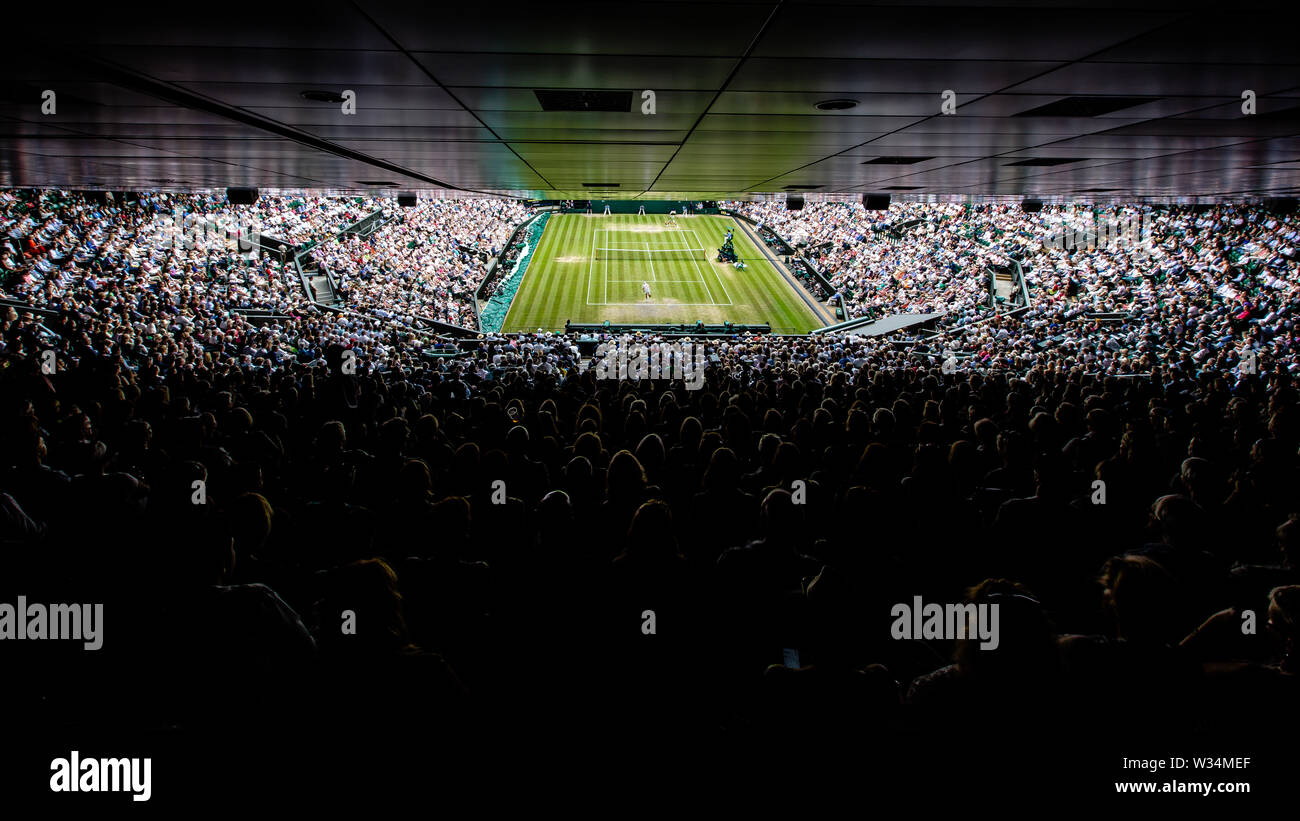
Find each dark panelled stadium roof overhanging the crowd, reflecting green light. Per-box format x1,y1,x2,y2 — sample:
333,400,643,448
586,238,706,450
0,0,1300,200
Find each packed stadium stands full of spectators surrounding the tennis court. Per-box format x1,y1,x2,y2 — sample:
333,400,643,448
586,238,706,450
0,191,1300,795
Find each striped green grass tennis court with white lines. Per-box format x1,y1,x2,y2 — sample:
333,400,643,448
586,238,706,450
502,214,824,334
